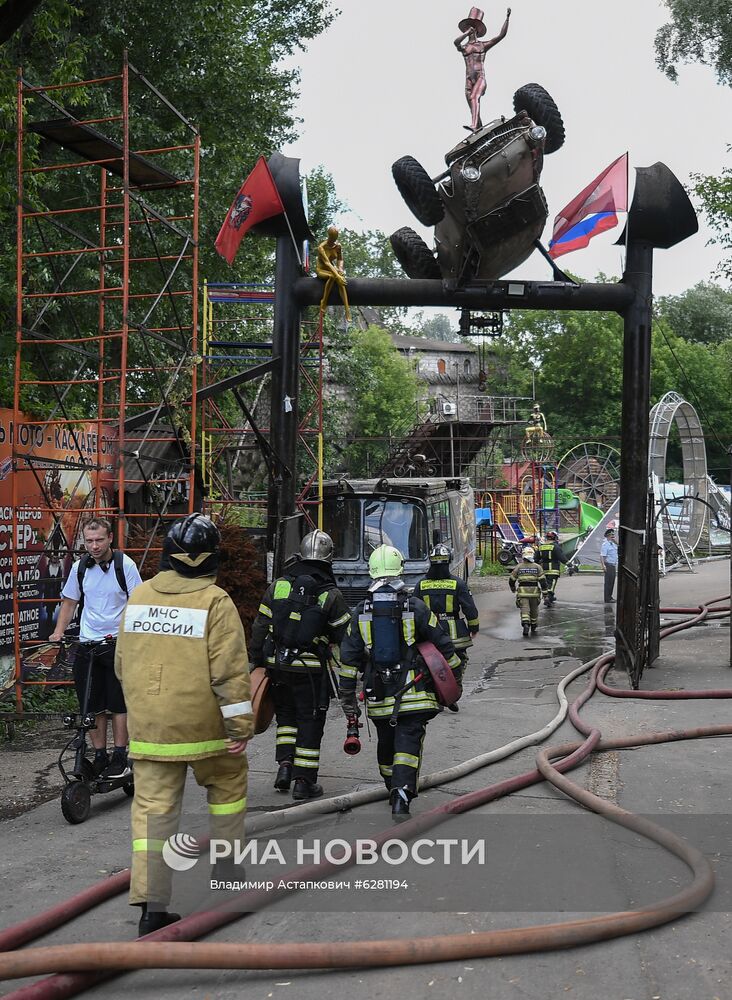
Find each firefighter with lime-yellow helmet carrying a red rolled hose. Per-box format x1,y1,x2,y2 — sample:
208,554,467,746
339,545,460,817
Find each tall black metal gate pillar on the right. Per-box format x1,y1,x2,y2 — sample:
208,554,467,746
615,240,658,674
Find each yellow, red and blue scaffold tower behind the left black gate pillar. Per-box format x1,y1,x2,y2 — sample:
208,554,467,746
198,282,323,527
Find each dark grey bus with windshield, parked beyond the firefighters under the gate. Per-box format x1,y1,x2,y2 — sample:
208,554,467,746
323,478,475,607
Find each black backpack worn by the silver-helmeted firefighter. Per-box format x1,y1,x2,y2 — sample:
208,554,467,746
272,574,331,664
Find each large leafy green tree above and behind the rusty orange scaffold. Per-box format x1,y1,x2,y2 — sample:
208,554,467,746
0,0,334,402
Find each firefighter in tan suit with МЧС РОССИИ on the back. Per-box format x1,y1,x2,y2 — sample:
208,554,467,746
115,514,254,934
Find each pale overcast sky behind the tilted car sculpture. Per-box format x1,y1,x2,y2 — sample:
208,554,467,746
283,0,732,295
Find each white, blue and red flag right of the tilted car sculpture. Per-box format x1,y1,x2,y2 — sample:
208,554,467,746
549,153,628,257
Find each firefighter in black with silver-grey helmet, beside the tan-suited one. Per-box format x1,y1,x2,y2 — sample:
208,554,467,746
251,531,351,799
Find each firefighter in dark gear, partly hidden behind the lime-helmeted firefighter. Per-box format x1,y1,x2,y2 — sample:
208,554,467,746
414,545,480,681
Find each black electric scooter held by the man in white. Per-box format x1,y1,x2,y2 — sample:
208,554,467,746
58,635,135,824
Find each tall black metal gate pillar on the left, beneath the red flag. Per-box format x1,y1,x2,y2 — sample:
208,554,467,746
267,233,301,574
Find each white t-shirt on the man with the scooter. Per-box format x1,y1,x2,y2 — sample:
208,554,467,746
61,555,142,642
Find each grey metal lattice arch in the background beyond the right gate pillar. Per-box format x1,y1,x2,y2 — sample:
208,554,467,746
648,392,708,549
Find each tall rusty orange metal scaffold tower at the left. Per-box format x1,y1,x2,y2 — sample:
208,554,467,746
12,55,200,701
